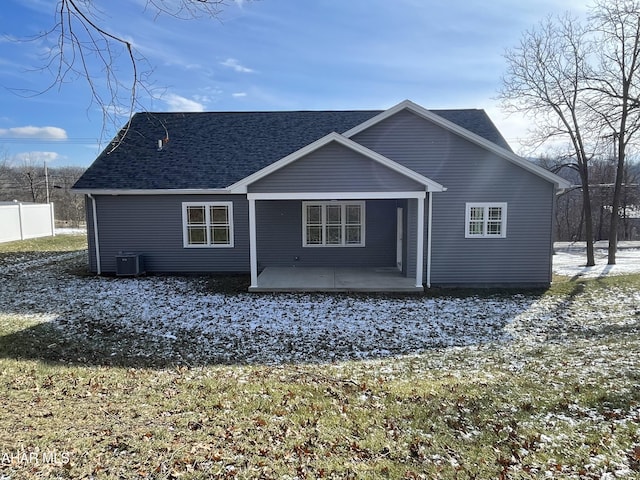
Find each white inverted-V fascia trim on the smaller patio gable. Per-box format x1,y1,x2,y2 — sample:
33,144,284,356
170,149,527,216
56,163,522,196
229,132,446,193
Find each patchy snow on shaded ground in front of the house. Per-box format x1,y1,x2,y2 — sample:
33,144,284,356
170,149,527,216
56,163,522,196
0,245,640,364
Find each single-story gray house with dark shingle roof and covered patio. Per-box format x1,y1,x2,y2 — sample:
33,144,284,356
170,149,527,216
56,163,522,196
74,101,568,291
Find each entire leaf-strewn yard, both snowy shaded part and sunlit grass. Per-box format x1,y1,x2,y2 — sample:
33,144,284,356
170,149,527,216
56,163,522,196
0,240,640,480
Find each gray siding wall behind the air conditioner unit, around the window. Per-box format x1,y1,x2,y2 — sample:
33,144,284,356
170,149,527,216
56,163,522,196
87,195,249,273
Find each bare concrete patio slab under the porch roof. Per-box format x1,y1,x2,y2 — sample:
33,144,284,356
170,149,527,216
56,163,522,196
249,267,424,293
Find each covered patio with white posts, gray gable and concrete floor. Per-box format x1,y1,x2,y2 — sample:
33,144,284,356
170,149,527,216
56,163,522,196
231,132,446,292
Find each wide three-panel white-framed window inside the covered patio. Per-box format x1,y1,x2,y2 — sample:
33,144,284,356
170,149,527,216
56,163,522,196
302,202,365,247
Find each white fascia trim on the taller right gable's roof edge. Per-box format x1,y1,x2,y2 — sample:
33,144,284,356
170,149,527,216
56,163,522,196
343,100,569,189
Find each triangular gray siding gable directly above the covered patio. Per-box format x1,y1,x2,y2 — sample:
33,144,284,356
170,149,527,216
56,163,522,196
249,142,424,193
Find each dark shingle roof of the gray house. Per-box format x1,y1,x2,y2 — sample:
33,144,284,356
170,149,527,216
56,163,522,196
74,109,510,190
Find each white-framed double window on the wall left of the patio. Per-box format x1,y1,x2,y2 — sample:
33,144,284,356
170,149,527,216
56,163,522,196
182,202,233,247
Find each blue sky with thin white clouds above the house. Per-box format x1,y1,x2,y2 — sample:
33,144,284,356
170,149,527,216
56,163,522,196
0,0,587,166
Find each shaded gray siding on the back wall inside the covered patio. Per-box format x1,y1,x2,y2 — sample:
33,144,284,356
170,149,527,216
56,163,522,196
256,200,402,269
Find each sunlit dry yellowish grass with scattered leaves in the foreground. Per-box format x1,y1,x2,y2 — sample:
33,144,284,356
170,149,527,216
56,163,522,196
0,237,640,480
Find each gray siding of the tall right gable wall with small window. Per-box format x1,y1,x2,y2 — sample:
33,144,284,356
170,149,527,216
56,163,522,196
353,111,554,286
